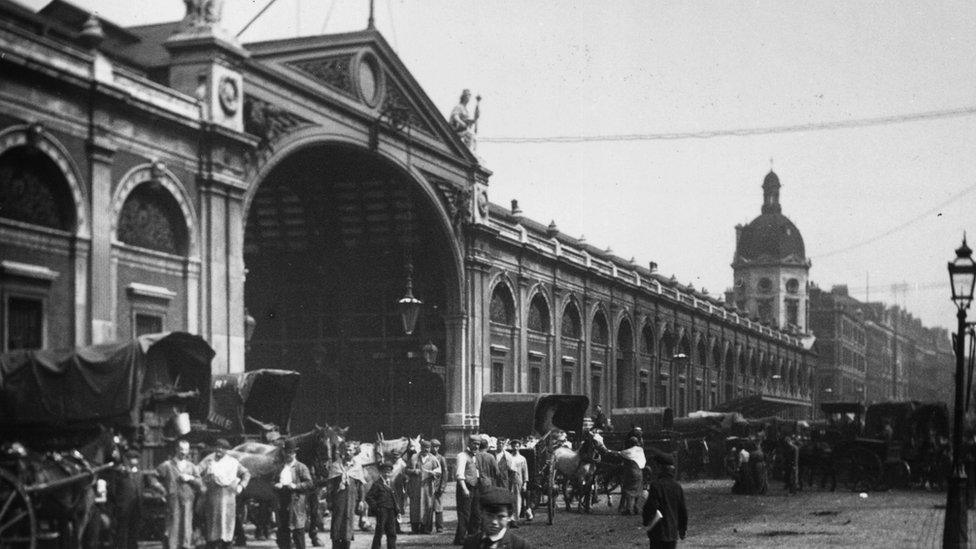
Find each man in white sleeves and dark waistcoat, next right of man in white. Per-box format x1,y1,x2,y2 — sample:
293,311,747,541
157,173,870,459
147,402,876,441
275,439,313,549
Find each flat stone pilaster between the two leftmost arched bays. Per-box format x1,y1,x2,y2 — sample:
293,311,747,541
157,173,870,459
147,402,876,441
88,131,118,344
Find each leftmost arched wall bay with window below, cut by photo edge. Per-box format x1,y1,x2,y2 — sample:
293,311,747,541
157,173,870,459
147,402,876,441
0,125,90,352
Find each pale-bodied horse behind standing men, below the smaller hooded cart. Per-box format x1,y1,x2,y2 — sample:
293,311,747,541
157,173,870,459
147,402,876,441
201,424,348,545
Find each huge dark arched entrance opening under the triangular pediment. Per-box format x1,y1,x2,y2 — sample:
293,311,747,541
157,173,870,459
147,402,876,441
244,143,458,440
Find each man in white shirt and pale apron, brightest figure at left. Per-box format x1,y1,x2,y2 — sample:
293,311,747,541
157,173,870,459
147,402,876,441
200,439,251,549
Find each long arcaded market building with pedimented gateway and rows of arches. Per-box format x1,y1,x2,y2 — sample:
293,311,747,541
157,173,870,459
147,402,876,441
0,0,813,447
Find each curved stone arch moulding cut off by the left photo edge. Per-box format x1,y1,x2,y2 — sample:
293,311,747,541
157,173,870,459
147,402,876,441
0,124,91,238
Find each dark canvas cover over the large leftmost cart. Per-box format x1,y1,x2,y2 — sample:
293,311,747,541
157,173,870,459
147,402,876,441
0,332,214,428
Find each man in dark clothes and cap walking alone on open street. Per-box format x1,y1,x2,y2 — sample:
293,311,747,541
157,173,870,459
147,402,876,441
643,454,688,549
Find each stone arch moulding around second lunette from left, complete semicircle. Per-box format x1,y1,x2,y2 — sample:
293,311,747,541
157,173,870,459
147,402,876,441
110,162,200,259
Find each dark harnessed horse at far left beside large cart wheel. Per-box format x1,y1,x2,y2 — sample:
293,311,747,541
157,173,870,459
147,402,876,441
0,426,121,548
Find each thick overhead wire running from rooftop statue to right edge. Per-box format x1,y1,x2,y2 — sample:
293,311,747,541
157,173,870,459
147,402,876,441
478,105,976,144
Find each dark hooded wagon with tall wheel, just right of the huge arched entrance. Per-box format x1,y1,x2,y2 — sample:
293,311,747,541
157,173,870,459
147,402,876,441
479,393,590,524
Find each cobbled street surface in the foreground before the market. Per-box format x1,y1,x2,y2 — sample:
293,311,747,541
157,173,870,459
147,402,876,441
140,480,976,549
